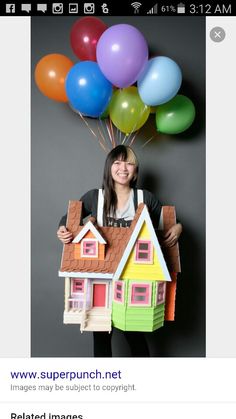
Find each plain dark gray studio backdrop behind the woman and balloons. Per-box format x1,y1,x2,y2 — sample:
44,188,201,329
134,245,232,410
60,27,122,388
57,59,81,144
31,16,205,357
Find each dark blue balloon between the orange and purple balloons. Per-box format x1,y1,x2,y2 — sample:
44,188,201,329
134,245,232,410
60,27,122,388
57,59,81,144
65,61,112,118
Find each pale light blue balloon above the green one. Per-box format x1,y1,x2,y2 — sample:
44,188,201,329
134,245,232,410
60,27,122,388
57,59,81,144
138,57,182,106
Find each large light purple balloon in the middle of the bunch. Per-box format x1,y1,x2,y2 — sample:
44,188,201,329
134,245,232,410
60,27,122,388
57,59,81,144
97,24,148,87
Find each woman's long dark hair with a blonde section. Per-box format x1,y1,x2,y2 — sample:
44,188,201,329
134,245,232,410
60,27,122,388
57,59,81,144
102,145,138,225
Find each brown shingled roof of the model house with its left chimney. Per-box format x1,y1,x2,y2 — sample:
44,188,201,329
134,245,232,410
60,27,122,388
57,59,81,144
60,201,179,277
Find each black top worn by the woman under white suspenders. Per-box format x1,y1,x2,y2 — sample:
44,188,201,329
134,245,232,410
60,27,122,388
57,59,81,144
59,189,162,229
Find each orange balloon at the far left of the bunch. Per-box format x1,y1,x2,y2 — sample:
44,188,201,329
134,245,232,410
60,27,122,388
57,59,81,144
34,54,74,102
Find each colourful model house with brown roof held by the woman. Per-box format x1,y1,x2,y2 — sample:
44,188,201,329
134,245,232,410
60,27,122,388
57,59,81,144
59,201,180,332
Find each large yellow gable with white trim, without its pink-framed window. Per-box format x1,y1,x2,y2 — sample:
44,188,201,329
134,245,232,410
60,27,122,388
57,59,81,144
114,206,171,281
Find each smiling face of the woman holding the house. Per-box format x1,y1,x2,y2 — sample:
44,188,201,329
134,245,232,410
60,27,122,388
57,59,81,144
111,158,137,186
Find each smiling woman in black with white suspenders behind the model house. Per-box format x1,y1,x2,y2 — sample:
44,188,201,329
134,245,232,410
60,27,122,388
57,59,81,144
57,145,182,357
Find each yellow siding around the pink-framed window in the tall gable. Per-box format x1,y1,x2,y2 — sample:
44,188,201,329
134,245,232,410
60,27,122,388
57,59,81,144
121,222,167,281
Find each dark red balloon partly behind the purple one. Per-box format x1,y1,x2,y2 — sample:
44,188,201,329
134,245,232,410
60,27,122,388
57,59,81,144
70,16,107,61
